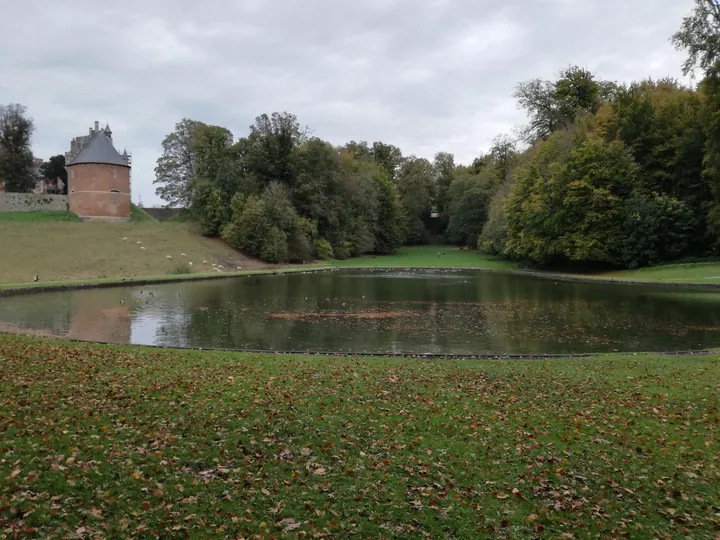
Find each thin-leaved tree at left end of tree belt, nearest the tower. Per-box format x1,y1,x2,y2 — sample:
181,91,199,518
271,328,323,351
153,118,205,206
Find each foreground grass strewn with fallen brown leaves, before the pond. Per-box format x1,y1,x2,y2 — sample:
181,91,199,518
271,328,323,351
0,336,720,538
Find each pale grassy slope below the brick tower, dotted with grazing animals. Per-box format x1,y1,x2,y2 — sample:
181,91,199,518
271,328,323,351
0,214,265,283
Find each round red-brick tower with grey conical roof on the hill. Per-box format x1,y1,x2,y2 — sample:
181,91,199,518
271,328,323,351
65,122,130,221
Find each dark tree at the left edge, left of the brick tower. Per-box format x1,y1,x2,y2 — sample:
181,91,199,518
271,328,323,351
0,103,35,193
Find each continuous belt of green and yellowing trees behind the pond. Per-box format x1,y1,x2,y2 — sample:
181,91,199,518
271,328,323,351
150,0,720,268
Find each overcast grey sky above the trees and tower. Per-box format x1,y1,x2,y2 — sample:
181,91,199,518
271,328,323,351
0,0,692,206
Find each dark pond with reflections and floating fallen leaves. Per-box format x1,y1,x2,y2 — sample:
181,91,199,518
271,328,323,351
0,270,720,355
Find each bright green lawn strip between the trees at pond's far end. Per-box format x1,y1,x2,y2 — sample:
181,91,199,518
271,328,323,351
334,246,517,270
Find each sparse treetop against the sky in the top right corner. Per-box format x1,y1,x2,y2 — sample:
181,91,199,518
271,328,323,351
672,0,720,75
